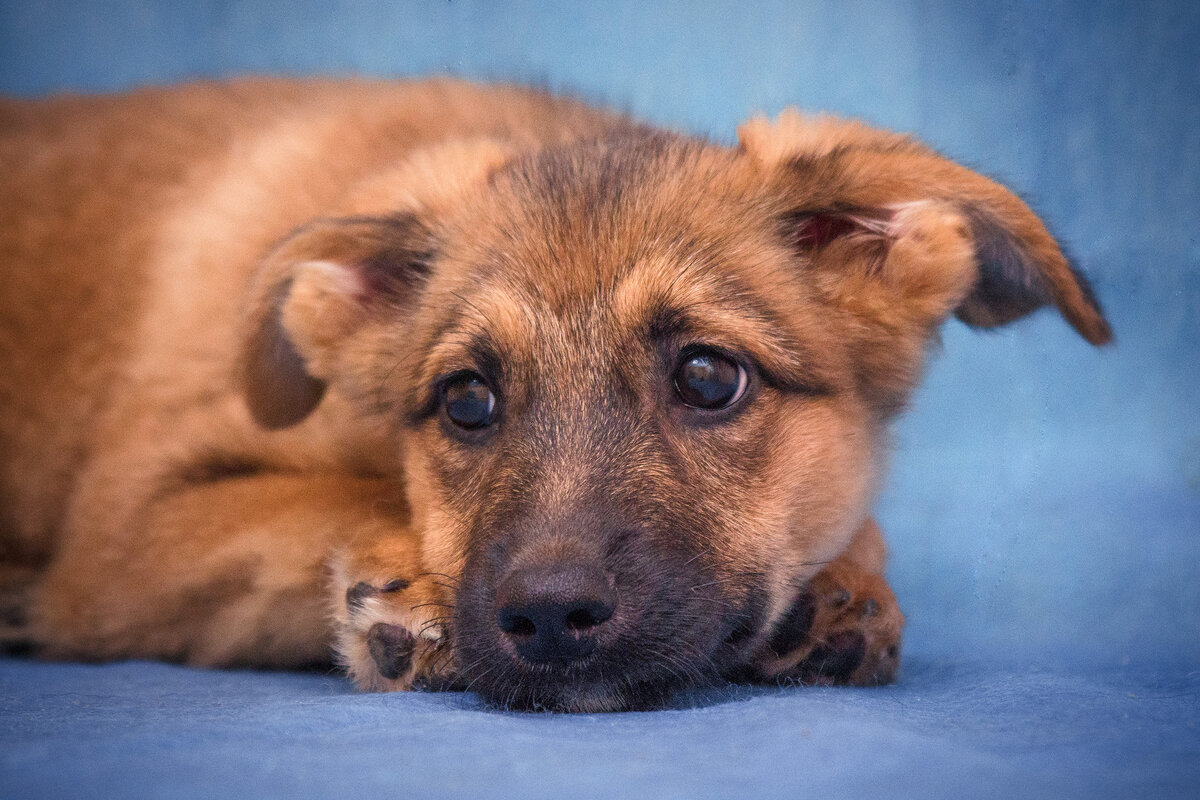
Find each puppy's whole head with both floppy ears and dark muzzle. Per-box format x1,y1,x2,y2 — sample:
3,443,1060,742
238,114,1109,710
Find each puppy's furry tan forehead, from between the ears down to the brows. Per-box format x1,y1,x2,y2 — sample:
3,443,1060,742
408,136,836,398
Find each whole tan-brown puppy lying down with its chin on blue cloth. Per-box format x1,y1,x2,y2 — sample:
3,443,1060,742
0,82,1109,710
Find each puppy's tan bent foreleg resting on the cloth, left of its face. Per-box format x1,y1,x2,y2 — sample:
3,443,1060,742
30,474,451,688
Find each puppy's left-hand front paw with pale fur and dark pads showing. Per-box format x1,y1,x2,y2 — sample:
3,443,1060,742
334,566,454,692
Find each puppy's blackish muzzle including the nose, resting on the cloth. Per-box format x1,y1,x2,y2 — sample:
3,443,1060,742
451,527,739,711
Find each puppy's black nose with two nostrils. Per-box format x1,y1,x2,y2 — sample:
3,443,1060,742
496,564,617,666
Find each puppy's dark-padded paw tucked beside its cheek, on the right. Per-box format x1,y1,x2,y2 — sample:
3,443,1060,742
750,521,904,686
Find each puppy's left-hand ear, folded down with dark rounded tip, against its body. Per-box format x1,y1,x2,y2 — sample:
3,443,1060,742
240,213,433,429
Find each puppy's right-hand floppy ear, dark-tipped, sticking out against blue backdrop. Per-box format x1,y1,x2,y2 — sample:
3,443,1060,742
738,110,1112,344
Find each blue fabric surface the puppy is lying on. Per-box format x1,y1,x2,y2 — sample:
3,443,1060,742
0,657,1200,800
